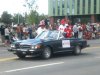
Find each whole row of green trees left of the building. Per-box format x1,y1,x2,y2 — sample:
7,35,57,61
1,0,47,24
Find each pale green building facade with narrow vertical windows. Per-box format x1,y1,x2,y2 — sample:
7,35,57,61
48,0,100,22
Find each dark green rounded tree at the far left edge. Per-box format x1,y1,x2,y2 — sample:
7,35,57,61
1,11,12,24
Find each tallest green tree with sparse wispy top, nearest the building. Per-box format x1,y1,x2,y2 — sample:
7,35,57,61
24,0,47,24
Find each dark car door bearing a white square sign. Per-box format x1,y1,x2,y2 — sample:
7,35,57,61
53,39,73,52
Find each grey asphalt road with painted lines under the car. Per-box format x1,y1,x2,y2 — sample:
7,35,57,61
0,39,100,75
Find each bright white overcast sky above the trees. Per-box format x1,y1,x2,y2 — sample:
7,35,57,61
0,0,48,15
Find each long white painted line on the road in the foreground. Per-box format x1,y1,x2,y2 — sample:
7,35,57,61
3,62,64,73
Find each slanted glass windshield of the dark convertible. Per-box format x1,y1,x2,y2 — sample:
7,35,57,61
36,31,59,39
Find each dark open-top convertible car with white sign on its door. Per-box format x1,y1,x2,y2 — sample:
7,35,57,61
8,30,88,59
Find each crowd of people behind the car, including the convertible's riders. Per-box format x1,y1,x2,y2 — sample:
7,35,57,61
0,19,100,45
